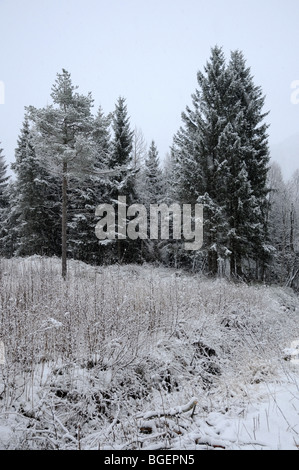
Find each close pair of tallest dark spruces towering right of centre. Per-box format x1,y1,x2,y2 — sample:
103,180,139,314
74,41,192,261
174,47,269,276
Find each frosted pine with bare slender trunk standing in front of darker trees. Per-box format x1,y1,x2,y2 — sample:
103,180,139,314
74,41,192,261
28,69,95,278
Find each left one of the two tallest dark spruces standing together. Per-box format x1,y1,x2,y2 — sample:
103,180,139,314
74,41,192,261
173,47,230,274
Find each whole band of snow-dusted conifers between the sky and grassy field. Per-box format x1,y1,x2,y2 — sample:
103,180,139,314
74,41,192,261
0,47,299,287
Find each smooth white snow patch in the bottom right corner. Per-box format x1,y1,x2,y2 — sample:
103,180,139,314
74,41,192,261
186,370,299,450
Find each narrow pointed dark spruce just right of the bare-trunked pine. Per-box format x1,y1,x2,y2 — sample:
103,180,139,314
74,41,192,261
105,97,140,263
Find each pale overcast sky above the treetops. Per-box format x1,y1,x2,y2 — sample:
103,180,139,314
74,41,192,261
0,0,299,178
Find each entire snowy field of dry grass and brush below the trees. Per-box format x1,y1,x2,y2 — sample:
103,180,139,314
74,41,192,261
0,256,299,450
